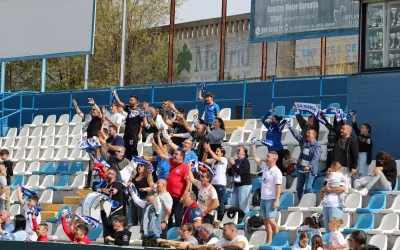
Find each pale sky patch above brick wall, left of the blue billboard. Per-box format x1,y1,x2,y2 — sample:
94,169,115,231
176,0,251,23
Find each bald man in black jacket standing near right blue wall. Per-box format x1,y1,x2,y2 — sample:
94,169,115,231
333,124,358,188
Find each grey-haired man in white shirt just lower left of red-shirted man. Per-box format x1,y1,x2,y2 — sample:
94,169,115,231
157,179,173,239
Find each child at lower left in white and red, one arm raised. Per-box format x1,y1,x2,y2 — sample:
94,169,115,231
17,186,41,241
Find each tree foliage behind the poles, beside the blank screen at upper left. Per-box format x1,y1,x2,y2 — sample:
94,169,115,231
6,0,183,91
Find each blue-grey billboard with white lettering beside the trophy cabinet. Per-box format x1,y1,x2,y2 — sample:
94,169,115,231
250,0,360,43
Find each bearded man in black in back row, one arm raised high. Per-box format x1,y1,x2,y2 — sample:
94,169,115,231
111,90,143,160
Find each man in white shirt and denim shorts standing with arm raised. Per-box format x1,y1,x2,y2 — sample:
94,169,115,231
252,144,282,244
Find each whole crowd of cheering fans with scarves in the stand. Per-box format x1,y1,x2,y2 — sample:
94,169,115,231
0,89,390,250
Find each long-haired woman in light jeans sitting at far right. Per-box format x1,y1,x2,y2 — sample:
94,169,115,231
349,151,397,196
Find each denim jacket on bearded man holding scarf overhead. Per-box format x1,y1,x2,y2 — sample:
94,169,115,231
290,128,322,175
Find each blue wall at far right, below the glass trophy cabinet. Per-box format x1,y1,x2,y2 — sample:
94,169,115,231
347,72,400,159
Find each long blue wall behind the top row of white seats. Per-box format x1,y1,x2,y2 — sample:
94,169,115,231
0,78,347,132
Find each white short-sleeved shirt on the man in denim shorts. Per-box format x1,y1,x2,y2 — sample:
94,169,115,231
261,162,282,200
